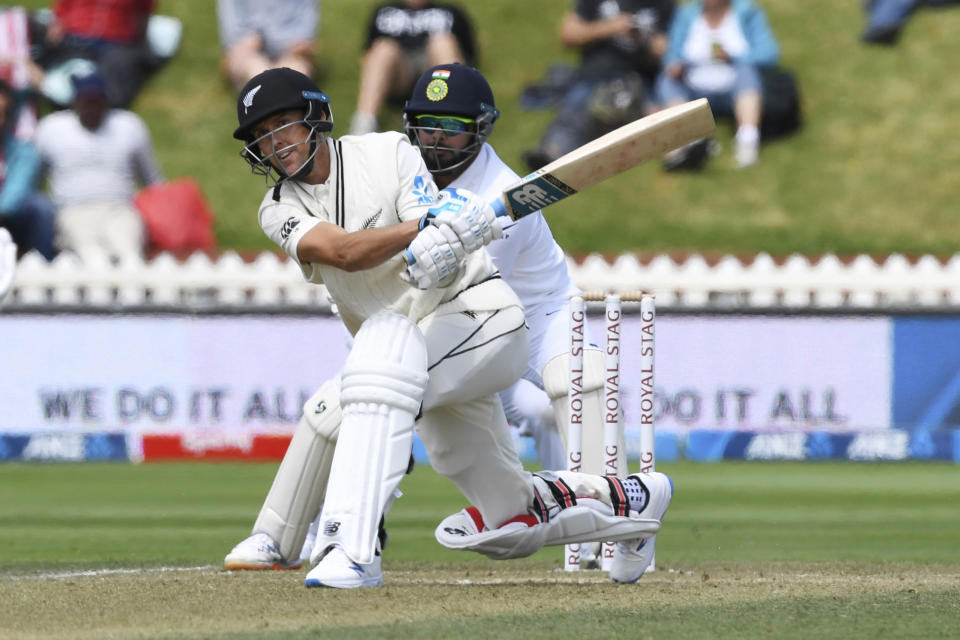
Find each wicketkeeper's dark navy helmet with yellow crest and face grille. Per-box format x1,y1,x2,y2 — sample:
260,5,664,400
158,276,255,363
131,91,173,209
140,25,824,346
403,63,500,174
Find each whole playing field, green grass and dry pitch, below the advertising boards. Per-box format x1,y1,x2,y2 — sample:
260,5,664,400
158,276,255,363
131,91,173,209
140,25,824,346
0,463,960,638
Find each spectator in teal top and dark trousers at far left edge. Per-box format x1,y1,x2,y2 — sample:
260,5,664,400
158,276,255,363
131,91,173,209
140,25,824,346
0,80,55,260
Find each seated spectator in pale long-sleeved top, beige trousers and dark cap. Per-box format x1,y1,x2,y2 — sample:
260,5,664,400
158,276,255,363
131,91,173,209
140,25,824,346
37,73,163,258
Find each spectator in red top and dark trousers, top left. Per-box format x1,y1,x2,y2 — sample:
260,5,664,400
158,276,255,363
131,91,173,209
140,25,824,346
37,0,179,108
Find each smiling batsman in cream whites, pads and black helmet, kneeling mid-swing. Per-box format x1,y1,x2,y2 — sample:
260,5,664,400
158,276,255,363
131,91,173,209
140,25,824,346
225,69,672,588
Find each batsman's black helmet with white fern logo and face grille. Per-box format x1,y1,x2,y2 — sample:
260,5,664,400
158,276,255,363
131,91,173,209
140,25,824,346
233,67,333,186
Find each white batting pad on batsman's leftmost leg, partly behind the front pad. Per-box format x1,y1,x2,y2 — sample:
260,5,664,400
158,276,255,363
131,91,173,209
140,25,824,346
253,380,341,561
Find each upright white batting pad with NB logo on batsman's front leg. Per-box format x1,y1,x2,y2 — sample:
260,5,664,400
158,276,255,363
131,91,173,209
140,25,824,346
311,312,427,564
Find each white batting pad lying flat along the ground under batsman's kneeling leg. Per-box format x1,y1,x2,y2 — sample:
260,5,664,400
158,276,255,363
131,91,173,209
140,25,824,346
434,498,660,560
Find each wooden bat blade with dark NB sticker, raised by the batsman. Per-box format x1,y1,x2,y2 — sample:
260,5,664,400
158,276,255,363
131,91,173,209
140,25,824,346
491,98,716,220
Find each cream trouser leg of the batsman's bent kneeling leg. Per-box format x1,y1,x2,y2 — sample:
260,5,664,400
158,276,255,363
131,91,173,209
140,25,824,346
416,306,533,526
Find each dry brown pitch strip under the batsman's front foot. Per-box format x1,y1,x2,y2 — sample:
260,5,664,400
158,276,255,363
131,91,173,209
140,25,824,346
0,563,960,639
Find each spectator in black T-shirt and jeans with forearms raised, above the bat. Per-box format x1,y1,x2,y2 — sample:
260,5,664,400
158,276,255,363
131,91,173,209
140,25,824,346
524,0,674,169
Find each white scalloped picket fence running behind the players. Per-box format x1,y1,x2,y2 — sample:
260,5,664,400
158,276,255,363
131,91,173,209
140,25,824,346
2,252,960,312
